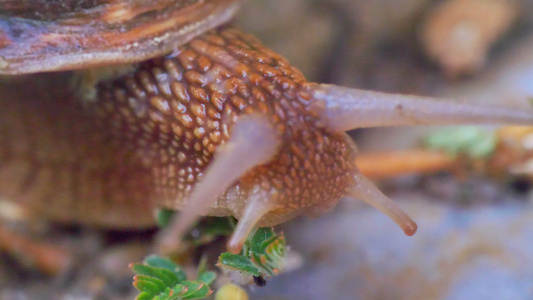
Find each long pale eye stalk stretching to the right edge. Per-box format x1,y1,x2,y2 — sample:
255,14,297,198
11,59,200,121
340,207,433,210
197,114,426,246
310,84,533,131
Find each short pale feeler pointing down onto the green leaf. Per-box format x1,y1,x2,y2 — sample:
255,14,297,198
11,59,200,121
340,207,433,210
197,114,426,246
228,187,274,254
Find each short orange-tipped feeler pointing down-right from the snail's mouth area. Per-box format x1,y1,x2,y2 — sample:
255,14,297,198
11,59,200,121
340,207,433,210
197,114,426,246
348,172,418,236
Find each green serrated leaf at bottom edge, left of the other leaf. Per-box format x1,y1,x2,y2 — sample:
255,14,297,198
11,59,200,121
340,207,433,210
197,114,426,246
130,255,216,300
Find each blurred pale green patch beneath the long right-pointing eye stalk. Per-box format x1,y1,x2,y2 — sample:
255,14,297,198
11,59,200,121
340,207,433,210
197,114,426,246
423,126,497,158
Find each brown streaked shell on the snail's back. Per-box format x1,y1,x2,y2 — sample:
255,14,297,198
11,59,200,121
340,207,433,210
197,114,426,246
0,0,242,74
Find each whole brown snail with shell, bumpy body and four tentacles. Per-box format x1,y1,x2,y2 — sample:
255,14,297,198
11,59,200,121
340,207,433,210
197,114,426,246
0,0,533,253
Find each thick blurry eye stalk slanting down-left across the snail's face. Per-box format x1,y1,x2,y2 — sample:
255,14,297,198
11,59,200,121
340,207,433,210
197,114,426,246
158,115,281,253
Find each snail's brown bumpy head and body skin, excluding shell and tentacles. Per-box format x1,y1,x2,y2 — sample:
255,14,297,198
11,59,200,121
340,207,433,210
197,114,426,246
0,28,355,227
